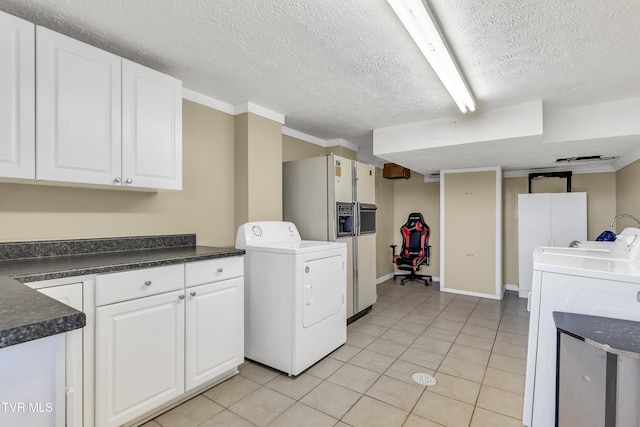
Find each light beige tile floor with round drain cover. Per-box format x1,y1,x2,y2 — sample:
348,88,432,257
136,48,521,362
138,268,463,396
144,280,529,427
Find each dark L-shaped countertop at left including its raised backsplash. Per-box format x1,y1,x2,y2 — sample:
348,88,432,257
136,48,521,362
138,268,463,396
0,235,244,348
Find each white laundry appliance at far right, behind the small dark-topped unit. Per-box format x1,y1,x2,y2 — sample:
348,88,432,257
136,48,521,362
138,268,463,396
523,229,640,427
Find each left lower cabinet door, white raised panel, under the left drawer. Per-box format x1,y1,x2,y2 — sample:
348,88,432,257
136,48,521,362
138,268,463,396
95,290,185,427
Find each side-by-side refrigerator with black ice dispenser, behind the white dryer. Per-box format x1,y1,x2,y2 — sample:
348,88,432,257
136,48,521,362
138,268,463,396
282,154,377,321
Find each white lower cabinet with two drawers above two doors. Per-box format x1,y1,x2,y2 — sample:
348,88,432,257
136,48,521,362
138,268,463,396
94,257,244,427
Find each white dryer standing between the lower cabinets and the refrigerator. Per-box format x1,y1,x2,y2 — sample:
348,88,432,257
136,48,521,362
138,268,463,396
236,221,347,375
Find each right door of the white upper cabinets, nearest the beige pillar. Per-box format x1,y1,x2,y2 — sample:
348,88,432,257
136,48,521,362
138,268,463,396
122,59,182,190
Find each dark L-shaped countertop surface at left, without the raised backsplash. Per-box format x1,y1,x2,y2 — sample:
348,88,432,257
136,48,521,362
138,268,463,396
0,246,245,348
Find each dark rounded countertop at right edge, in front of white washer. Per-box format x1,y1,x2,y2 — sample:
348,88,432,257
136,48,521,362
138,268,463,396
553,311,640,358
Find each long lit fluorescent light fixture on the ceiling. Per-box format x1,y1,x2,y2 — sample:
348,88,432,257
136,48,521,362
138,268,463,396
387,0,476,113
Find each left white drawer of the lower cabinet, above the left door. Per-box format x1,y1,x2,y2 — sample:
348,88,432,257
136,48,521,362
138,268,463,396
96,264,184,306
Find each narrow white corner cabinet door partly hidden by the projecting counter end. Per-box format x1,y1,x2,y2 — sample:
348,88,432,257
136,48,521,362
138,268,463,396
38,283,83,427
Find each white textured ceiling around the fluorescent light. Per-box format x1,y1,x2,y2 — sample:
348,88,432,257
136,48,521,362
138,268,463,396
0,0,640,171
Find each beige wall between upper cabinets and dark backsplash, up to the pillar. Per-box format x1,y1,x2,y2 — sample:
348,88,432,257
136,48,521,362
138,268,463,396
0,101,235,246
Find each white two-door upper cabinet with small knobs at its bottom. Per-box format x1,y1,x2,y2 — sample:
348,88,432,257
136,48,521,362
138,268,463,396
30,18,182,190
